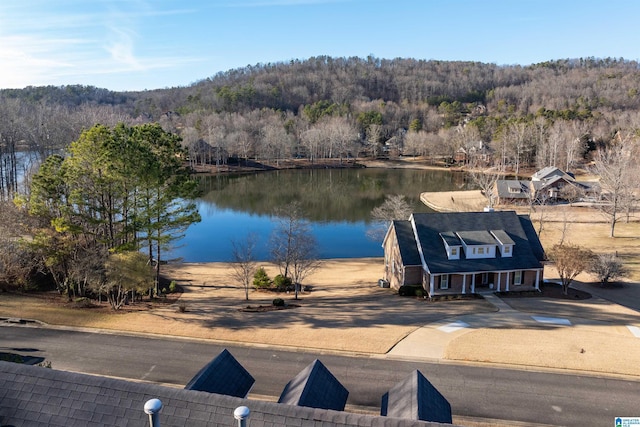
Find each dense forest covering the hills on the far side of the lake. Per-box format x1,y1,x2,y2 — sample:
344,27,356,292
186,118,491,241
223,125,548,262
0,56,640,200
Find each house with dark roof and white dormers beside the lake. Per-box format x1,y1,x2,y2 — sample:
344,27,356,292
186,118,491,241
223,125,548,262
383,211,545,297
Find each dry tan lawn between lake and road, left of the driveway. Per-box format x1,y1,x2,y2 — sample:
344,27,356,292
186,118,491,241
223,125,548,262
0,258,494,354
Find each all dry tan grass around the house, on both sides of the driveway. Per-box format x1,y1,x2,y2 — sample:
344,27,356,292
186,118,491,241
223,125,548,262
0,201,640,376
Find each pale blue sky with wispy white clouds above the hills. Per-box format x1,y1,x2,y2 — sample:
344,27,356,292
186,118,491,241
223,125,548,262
0,0,640,91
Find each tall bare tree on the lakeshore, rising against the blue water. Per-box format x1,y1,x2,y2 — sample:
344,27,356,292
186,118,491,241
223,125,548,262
271,202,320,299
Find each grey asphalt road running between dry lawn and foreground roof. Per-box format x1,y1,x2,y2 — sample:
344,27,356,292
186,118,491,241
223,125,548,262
0,326,640,426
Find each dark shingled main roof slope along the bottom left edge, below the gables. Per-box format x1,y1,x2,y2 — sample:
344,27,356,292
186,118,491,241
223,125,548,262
0,361,452,427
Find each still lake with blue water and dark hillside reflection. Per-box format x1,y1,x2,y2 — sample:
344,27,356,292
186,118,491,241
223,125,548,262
168,168,471,262
